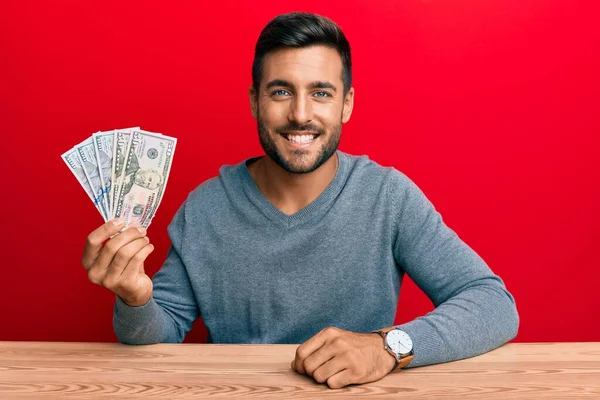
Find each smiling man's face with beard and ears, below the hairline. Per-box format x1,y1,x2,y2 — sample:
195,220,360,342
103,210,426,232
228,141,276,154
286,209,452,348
250,46,354,174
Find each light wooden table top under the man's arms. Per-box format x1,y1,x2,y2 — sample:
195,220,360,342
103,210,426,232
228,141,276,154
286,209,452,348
0,342,600,400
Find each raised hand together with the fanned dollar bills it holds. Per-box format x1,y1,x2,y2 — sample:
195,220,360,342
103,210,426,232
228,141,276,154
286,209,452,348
61,127,177,306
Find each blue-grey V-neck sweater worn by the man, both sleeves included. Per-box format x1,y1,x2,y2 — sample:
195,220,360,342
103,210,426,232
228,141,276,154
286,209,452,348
113,151,519,367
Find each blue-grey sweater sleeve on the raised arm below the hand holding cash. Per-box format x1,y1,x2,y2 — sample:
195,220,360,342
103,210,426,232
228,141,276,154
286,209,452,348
113,203,199,344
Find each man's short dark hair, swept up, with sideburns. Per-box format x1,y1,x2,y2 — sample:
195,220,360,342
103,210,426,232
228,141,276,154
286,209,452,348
252,12,352,95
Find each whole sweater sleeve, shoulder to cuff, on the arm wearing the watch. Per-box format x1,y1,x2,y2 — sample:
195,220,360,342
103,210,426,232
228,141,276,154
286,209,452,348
390,173,519,367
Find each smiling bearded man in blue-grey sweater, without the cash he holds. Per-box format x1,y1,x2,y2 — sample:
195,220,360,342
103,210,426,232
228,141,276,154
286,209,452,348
83,13,519,388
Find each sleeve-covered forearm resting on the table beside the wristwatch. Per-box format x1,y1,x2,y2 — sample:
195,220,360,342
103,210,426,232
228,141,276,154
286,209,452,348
398,277,519,367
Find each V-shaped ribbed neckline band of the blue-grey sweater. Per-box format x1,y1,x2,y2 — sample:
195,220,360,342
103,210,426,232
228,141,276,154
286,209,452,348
239,150,349,228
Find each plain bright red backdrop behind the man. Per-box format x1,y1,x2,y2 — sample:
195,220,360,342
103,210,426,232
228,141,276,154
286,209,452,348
0,0,600,341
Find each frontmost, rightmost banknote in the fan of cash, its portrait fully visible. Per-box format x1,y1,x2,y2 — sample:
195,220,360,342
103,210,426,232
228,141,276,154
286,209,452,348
113,130,177,228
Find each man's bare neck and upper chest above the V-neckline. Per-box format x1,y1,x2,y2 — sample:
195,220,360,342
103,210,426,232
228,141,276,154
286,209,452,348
248,153,338,215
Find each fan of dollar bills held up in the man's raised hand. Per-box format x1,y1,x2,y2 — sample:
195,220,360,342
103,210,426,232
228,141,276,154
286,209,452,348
61,127,177,228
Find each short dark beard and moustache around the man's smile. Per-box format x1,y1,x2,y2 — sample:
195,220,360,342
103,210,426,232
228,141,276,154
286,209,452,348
258,116,342,174
